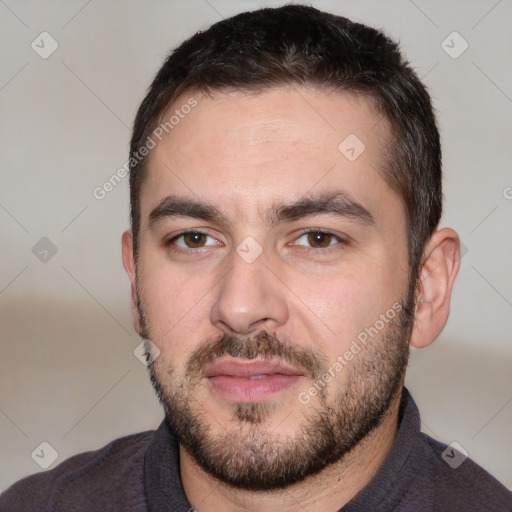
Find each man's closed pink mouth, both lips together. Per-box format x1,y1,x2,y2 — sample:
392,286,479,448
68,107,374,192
204,358,304,403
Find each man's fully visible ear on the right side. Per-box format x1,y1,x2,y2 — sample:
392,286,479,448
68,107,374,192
410,228,460,348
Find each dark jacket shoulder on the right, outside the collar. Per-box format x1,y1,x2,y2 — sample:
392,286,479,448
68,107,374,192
418,433,512,512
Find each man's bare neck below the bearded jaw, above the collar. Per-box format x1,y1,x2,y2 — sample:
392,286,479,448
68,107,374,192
180,393,401,512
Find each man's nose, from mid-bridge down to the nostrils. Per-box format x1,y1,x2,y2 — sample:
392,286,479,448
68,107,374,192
210,252,289,334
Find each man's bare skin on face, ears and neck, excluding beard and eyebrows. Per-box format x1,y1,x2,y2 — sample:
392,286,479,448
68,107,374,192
123,88,459,512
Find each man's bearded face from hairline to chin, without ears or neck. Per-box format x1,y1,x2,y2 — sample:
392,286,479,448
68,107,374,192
131,88,410,489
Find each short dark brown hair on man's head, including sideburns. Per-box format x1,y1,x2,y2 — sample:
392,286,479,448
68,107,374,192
130,5,442,281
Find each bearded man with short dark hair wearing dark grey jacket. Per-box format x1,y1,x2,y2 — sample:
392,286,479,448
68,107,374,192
0,5,512,512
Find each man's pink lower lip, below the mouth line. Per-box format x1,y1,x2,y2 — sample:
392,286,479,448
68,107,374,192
208,373,301,402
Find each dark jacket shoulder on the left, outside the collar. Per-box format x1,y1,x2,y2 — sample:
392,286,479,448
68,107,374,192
0,431,153,512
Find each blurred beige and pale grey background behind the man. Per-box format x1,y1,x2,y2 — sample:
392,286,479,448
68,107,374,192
0,0,512,489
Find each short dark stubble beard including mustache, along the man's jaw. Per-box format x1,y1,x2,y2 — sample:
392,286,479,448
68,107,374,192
139,299,414,491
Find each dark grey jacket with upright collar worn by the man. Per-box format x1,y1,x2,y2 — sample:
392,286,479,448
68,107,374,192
0,389,512,512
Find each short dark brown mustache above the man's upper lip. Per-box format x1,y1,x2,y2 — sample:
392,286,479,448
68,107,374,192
186,331,328,380
